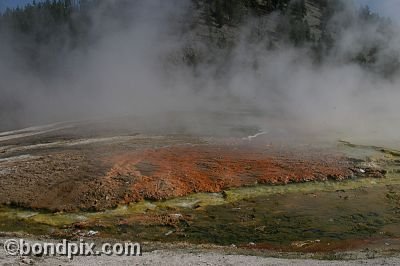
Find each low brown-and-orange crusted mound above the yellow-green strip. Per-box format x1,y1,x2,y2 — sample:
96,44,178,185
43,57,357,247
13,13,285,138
0,145,383,211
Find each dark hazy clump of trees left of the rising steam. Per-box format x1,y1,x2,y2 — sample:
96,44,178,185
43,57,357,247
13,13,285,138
0,0,90,72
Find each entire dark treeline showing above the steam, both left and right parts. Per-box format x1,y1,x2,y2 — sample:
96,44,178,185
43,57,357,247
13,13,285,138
0,0,399,75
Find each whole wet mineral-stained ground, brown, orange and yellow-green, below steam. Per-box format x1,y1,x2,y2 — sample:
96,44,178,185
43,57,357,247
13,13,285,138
0,119,400,255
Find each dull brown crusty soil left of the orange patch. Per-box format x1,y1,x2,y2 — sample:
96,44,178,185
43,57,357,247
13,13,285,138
0,152,122,211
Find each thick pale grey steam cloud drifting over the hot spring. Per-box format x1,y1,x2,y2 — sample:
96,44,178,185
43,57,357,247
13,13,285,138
0,0,400,140
